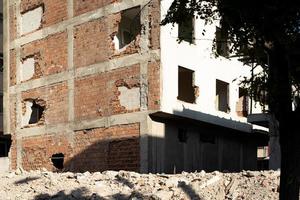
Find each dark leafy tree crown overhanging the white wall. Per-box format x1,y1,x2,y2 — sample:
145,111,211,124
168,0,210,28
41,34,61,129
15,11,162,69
161,0,300,106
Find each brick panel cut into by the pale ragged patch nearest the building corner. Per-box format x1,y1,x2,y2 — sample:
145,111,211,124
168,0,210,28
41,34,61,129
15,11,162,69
74,65,140,120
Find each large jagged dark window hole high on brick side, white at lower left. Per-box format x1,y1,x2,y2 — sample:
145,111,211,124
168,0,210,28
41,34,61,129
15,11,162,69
114,7,141,49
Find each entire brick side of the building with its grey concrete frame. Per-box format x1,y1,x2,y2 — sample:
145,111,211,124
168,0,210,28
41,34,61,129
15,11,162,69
7,0,161,171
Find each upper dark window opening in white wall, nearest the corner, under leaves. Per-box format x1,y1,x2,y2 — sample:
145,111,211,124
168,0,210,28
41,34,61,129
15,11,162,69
178,16,194,43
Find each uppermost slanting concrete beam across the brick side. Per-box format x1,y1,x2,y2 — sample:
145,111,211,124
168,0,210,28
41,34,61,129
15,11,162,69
10,0,146,49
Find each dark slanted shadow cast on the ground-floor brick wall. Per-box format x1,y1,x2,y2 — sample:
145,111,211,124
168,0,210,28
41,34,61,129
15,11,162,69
62,136,140,172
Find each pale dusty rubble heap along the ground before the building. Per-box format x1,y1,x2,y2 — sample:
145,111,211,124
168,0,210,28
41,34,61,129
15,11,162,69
0,169,280,200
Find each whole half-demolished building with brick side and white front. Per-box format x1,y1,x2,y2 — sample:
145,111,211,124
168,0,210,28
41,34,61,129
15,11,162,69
4,0,266,173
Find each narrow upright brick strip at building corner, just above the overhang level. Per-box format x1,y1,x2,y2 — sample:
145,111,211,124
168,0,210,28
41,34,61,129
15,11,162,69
148,61,160,110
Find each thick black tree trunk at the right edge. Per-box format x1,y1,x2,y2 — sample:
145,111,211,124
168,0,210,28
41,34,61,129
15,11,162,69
268,45,300,200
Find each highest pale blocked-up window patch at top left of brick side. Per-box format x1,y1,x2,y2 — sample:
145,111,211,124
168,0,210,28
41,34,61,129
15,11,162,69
21,6,43,35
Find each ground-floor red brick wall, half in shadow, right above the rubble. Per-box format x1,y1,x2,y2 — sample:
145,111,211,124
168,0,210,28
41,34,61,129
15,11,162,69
22,124,140,172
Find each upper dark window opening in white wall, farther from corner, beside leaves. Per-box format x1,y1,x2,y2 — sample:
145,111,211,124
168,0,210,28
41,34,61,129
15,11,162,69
215,27,229,57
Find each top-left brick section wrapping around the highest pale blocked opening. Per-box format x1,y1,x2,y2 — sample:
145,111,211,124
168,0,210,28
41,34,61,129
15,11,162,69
20,0,68,28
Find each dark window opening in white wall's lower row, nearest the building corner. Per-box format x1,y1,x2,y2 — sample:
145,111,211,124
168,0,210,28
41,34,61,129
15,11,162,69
177,66,196,103
